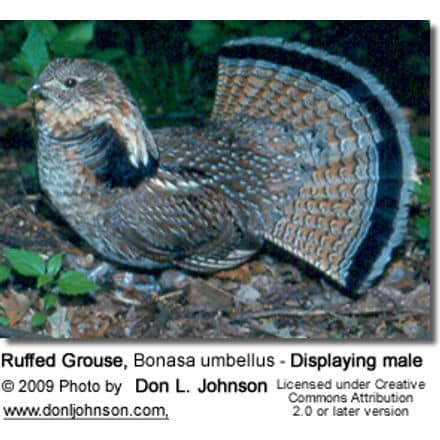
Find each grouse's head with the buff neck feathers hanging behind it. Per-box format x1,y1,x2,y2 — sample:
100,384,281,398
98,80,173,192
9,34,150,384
28,58,159,172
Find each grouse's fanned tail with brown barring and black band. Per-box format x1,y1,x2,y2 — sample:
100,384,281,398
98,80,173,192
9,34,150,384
212,38,415,291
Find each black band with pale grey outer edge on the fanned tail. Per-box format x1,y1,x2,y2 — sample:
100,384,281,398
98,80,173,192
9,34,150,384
220,38,414,290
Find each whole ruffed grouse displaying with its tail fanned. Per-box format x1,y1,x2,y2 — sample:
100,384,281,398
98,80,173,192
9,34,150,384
31,38,415,291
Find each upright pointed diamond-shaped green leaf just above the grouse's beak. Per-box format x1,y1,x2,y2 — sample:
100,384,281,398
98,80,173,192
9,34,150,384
13,25,49,78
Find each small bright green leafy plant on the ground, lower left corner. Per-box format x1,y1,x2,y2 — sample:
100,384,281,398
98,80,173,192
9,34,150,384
0,249,100,328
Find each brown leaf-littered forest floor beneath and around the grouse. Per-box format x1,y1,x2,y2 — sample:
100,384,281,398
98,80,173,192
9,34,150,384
0,106,432,340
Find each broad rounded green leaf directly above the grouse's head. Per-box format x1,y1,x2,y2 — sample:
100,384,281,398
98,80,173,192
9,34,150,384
50,21,95,56
